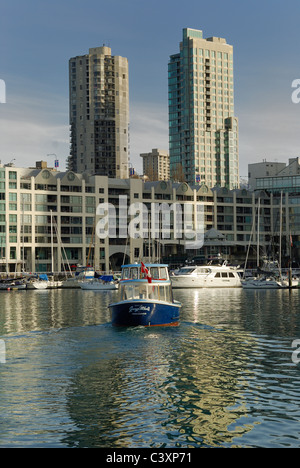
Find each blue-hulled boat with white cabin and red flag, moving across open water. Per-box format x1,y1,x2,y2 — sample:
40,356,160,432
109,263,181,327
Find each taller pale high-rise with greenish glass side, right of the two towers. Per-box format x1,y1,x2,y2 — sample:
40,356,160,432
168,28,239,189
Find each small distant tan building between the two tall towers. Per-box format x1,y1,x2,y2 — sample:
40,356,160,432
140,149,170,180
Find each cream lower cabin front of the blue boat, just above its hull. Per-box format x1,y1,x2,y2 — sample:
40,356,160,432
119,283,172,302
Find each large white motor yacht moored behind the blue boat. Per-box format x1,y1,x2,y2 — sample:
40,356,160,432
170,260,242,288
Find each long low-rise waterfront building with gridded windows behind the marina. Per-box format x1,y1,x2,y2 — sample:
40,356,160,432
0,163,300,274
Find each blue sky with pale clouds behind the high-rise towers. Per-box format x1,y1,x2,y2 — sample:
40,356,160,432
0,0,300,177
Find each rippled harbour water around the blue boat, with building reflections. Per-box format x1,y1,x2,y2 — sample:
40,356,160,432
0,289,300,448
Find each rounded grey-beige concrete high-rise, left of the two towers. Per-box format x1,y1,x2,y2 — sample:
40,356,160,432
68,46,129,179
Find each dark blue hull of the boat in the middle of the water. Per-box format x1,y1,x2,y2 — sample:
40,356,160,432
109,300,181,327
